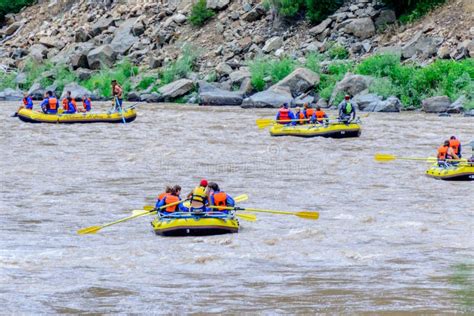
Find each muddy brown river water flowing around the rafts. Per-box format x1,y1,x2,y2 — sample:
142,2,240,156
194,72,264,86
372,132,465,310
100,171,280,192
0,102,474,315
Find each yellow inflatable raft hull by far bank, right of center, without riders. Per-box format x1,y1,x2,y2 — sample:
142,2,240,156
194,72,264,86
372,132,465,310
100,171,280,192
270,123,361,138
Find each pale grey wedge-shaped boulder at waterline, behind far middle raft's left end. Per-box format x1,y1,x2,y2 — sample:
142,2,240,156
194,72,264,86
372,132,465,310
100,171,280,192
242,87,293,108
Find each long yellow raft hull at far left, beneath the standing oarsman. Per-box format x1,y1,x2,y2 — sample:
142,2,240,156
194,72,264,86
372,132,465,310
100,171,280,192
18,108,137,124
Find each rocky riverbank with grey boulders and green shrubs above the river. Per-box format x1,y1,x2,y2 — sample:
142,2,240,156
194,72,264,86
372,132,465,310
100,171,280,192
0,0,474,112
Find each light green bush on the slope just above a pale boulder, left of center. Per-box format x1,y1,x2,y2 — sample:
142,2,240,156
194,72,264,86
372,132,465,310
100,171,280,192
161,45,199,84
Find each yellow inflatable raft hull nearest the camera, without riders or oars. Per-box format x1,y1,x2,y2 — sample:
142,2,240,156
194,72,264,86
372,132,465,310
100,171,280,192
151,212,239,236
